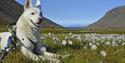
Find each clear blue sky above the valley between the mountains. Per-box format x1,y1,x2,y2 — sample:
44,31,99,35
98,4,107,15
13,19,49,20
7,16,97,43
17,0,125,27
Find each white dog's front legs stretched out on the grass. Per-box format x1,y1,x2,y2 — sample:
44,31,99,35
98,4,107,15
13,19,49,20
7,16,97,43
21,46,61,63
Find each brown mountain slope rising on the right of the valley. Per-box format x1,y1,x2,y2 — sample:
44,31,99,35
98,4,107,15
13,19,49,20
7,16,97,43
87,6,125,30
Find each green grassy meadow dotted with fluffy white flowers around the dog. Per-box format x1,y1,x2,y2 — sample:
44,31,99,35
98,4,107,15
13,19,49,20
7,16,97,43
0,25,125,63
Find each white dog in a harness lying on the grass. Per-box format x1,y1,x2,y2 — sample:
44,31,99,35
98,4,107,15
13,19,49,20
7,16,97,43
0,0,67,63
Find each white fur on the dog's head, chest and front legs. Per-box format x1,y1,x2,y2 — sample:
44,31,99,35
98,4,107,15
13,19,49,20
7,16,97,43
16,0,60,63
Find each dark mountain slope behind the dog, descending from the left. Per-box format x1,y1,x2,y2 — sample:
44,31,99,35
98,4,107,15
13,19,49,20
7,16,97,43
0,0,63,28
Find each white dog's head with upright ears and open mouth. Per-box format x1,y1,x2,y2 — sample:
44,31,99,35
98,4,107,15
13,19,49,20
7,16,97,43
23,0,43,27
